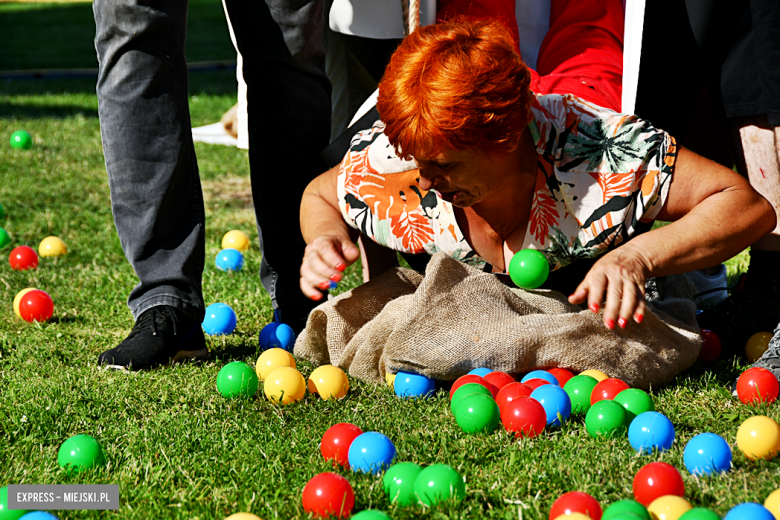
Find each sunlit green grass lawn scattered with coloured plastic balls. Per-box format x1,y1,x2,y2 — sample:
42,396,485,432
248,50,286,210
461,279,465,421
0,1,780,520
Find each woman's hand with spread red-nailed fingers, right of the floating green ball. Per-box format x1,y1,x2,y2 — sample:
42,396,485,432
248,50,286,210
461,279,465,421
569,246,649,330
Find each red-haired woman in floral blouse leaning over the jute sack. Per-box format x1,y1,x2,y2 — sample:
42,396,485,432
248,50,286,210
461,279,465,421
301,21,775,329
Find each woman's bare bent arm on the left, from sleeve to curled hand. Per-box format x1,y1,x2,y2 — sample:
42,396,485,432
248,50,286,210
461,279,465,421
300,162,360,300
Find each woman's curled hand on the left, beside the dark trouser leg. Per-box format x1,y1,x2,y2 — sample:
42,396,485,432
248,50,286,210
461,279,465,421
301,235,360,300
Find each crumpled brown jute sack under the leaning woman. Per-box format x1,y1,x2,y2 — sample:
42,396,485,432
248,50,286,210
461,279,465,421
295,253,701,389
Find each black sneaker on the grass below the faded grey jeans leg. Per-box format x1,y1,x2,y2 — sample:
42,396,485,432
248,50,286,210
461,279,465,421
98,305,209,370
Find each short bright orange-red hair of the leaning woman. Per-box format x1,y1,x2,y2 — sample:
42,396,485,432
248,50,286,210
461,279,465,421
377,20,533,159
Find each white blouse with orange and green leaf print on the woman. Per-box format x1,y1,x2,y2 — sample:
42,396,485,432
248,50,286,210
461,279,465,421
338,94,677,269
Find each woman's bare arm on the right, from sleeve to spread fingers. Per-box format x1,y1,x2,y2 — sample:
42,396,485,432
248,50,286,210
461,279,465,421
569,147,776,329
